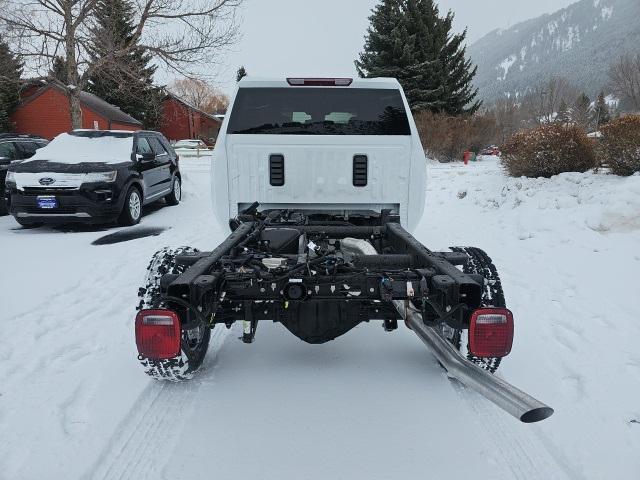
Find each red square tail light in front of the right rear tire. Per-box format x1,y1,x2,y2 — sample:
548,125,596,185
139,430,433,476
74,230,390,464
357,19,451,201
469,308,513,357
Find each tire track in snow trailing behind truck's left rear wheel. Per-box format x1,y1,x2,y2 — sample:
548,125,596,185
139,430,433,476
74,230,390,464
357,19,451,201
82,327,228,480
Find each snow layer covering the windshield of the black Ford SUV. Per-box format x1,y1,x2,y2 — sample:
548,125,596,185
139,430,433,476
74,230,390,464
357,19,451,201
26,133,133,164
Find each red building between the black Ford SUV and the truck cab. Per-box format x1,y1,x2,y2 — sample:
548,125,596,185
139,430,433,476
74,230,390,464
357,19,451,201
160,94,222,143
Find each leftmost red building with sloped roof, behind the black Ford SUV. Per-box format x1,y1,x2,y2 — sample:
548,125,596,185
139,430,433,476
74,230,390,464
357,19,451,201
11,82,142,139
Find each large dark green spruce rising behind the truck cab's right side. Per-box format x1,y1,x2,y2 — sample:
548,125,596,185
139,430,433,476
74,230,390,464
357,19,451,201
355,0,481,115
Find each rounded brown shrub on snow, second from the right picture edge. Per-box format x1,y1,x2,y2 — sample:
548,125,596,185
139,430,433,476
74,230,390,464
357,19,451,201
501,124,596,178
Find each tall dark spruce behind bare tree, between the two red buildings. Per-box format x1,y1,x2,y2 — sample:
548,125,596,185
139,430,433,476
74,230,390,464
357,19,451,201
88,0,163,129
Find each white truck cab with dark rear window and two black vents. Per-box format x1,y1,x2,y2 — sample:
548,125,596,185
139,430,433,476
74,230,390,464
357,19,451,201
212,77,426,231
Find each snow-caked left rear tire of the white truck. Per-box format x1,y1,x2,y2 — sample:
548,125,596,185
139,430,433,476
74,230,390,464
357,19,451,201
137,247,211,382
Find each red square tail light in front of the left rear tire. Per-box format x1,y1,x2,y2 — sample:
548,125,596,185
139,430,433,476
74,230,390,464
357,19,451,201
136,310,181,360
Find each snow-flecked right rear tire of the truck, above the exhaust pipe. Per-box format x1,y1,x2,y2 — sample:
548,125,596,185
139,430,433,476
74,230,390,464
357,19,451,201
444,247,507,373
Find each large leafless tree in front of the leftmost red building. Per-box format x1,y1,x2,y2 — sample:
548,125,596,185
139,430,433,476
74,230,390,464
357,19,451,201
0,0,242,128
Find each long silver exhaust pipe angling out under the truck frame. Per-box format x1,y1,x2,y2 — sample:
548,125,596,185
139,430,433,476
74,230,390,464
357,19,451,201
341,238,553,423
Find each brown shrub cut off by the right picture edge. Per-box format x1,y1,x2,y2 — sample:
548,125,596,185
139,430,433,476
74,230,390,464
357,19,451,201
600,115,640,176
